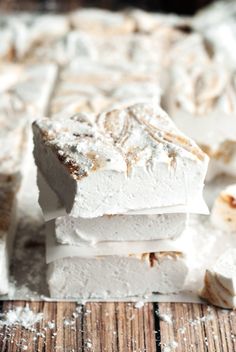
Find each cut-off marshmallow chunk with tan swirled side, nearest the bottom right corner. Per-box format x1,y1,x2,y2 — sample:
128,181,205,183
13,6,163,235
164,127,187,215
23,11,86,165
201,249,236,309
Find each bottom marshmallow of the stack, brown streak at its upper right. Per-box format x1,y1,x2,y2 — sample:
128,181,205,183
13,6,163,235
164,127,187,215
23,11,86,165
47,252,188,299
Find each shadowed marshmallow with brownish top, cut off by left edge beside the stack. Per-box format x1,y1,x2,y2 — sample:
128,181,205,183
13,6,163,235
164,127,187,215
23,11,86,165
0,175,19,295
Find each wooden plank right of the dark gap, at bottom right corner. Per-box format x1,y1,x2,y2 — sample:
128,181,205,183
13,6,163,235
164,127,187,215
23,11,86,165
159,303,236,352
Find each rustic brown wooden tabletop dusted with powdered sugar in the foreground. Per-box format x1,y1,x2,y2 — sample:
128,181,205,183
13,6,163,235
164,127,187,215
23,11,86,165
0,301,236,352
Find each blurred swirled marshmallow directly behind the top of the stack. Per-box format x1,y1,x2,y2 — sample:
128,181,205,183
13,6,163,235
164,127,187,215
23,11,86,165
50,77,161,117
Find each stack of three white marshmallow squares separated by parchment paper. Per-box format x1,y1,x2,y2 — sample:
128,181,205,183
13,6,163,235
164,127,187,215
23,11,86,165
33,102,208,299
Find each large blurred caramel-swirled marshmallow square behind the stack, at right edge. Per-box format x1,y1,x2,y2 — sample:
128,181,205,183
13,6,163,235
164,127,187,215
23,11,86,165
165,38,236,180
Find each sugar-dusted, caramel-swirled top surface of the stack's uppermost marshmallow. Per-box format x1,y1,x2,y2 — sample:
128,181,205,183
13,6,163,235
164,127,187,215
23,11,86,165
34,104,206,179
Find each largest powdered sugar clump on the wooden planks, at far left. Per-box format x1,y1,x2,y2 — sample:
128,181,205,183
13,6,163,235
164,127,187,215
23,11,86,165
0,305,43,329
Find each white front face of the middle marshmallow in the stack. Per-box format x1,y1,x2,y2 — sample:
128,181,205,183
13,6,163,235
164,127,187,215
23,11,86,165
55,214,187,245
